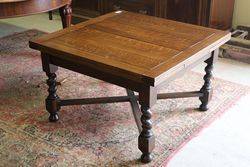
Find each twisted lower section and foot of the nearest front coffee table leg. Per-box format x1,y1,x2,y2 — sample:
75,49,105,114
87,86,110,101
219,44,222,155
138,106,155,163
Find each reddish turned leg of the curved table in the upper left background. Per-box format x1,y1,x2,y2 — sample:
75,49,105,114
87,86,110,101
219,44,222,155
59,5,72,28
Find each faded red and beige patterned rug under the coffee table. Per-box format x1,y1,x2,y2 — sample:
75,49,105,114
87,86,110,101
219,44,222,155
0,30,249,167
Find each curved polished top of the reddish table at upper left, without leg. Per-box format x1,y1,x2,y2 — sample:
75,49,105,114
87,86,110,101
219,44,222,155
0,0,71,19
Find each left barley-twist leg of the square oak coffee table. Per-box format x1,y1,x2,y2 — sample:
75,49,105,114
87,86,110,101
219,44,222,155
46,73,60,122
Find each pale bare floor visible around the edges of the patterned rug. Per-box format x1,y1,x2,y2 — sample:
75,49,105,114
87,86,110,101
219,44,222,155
0,14,250,167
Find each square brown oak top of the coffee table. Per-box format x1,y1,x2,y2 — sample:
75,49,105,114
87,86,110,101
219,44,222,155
30,11,231,85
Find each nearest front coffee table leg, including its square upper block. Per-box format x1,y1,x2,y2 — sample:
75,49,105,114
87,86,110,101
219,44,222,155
138,88,157,163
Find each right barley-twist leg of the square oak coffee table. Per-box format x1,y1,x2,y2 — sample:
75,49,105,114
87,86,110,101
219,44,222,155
199,51,217,111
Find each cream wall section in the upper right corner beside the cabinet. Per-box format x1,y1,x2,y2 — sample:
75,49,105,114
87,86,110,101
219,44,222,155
233,0,250,27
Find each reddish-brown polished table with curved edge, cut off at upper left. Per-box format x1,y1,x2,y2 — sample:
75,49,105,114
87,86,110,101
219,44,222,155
0,0,72,28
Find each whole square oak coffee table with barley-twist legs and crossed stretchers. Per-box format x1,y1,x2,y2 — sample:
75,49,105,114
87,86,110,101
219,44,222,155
30,11,231,163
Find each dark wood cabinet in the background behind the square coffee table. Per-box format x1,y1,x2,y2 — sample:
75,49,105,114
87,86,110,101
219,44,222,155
73,0,234,30
